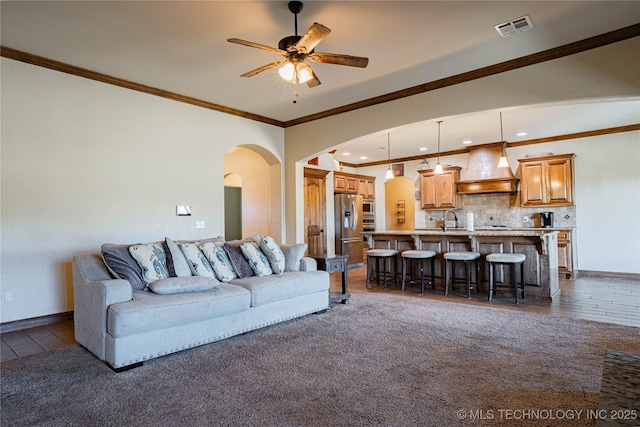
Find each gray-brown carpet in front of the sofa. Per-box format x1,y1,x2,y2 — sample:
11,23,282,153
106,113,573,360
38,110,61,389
1,293,640,427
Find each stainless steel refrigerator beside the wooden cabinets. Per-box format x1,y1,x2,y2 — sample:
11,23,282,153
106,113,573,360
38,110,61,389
334,194,363,267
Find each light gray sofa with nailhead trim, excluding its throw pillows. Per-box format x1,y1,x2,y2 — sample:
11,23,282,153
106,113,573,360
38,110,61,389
72,244,329,371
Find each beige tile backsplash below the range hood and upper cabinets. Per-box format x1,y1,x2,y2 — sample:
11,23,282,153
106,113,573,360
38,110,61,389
416,193,576,228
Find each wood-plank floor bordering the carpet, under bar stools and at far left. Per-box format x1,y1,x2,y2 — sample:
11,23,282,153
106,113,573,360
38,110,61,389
0,267,640,362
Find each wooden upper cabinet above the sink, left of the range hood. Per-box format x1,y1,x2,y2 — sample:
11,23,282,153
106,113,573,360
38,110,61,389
419,166,462,209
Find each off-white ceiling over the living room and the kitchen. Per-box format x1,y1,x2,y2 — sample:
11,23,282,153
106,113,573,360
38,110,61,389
0,1,640,163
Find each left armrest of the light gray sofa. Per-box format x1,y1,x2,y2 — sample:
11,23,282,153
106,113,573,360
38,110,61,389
72,255,133,360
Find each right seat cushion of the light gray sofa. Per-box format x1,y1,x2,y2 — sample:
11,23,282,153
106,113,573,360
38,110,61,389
230,271,329,307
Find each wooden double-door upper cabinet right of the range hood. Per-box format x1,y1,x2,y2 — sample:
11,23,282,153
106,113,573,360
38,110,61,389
518,154,575,207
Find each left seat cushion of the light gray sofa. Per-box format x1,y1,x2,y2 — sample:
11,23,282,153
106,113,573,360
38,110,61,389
107,283,251,338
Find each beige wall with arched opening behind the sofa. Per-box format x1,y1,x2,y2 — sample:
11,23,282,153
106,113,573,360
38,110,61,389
0,58,284,323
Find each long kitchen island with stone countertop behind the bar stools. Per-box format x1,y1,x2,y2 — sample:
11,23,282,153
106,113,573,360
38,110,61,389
363,227,560,300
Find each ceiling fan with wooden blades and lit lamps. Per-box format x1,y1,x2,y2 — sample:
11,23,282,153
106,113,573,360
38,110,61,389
227,1,369,87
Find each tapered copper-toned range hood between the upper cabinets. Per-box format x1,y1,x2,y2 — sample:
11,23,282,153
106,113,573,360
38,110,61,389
458,143,518,194
